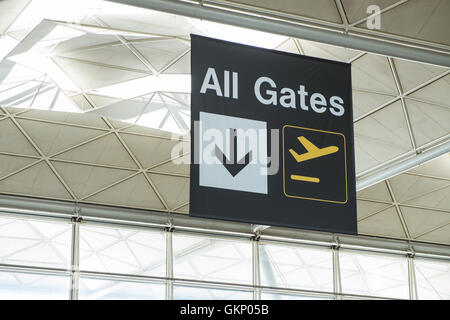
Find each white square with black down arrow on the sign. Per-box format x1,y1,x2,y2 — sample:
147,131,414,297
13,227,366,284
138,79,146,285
198,112,267,194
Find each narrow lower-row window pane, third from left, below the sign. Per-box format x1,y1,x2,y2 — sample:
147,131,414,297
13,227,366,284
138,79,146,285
173,286,253,300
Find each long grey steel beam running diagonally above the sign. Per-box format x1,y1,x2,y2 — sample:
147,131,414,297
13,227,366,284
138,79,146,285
106,0,450,67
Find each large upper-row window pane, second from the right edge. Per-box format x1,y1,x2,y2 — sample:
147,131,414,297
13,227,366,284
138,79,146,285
339,250,409,299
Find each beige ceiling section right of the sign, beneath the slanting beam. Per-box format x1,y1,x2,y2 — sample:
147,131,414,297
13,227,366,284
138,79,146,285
357,154,450,243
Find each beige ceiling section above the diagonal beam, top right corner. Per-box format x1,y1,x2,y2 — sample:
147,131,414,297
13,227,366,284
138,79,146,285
209,0,450,49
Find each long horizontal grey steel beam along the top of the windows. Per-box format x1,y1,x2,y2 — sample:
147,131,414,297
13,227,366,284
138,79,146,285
0,195,450,259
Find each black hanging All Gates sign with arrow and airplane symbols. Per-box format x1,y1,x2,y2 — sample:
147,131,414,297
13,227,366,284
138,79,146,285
190,35,356,234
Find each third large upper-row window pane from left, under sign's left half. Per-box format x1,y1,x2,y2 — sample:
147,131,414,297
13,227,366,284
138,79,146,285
173,233,252,284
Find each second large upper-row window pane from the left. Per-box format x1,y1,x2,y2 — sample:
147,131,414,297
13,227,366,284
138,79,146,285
80,225,166,276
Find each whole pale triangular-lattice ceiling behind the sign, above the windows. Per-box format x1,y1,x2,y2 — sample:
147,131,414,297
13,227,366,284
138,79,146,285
0,0,450,244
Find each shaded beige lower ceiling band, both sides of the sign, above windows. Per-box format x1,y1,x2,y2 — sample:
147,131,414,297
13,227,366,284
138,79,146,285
0,107,450,244
